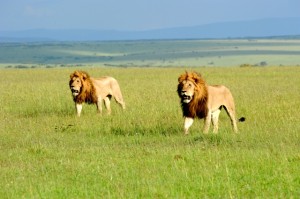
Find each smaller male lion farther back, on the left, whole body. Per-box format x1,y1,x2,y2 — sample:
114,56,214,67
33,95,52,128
69,71,125,117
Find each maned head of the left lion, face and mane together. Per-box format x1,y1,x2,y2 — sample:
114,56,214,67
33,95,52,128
69,71,97,103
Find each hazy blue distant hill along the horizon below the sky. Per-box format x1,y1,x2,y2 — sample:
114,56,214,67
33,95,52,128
0,18,300,42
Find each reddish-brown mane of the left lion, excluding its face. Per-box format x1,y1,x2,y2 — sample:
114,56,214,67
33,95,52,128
69,71,98,104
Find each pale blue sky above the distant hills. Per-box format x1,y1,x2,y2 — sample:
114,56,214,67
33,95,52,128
0,0,300,31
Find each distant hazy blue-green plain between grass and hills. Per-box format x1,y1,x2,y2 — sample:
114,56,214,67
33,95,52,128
0,39,300,68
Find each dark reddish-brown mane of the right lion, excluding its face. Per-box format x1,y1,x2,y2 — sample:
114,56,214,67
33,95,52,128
177,72,208,119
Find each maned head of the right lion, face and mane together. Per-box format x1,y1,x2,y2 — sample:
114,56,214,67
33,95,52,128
177,72,208,118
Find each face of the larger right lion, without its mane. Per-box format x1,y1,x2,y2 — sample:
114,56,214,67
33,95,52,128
178,80,196,104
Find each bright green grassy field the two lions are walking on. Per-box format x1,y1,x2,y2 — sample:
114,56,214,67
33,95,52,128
0,67,300,198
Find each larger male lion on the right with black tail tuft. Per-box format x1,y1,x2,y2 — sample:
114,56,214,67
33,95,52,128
177,72,245,134
